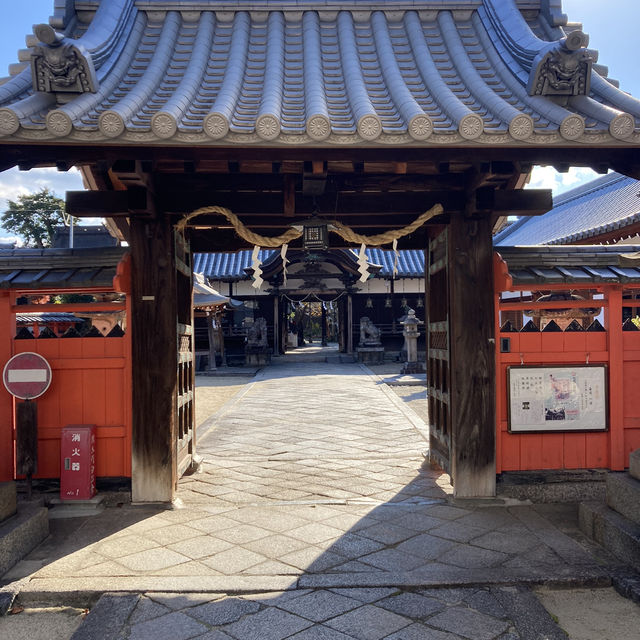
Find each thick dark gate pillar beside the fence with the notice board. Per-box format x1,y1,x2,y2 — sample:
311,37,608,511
448,214,496,497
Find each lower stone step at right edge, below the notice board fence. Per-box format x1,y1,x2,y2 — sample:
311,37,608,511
578,502,640,571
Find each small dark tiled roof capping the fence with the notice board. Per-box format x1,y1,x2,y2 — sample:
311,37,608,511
496,245,640,286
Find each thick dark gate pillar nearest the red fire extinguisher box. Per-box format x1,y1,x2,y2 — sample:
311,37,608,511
130,217,177,502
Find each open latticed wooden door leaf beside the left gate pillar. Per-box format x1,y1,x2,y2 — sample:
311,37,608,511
174,232,196,480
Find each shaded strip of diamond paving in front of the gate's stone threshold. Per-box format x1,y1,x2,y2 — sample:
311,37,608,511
72,587,567,640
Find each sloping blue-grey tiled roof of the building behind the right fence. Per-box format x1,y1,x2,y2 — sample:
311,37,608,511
494,173,640,246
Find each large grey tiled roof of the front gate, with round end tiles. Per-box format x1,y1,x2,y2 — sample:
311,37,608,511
0,0,640,147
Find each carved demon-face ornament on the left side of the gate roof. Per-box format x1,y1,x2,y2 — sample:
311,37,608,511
31,24,98,98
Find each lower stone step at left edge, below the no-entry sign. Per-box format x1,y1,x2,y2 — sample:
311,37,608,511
0,502,49,575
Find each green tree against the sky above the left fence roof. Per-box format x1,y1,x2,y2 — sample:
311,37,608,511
0,188,64,248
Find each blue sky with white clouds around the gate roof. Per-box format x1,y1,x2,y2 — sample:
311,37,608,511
0,0,640,237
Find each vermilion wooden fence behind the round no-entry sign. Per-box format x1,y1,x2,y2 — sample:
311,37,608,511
0,291,131,481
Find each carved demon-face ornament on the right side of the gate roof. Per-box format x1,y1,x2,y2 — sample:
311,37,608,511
527,31,596,97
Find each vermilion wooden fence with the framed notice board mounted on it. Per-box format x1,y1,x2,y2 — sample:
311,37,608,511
496,265,640,473
